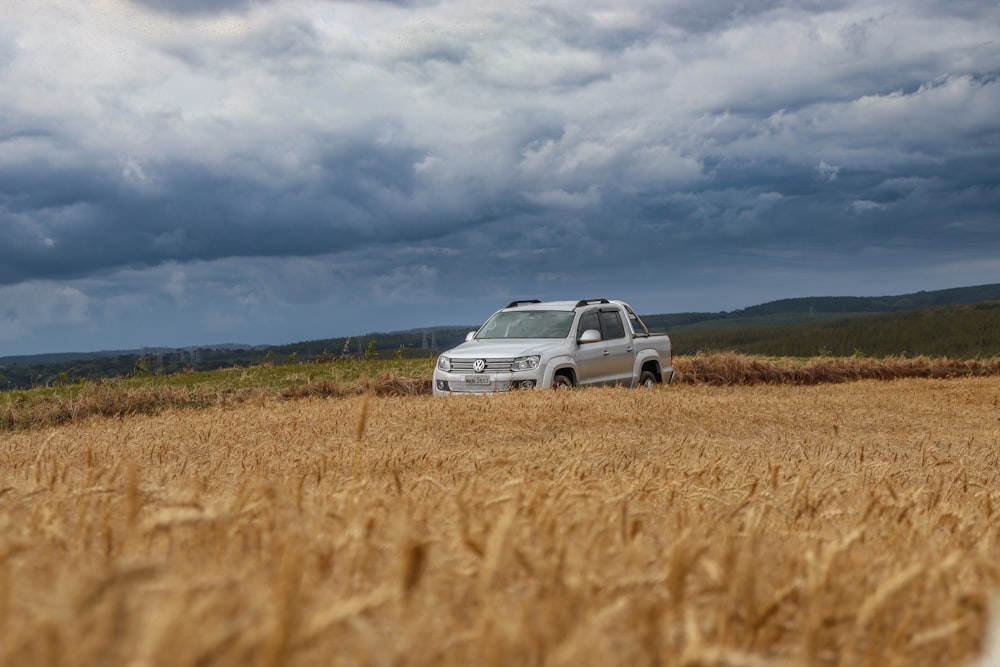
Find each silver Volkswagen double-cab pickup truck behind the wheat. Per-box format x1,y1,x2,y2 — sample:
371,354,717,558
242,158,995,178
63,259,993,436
434,299,674,396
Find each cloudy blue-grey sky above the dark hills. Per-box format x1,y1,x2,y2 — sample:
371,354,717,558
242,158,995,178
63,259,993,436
0,0,1000,356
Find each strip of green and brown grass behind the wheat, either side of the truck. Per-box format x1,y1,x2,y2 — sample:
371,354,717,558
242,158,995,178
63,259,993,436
7,353,1000,431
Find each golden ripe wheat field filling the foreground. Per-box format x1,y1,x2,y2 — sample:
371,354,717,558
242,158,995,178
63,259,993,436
0,377,1000,667
